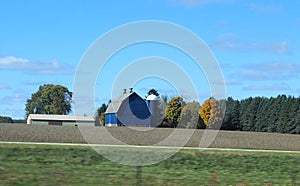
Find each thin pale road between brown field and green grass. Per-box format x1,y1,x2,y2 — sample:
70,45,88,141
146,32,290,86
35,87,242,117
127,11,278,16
0,141,300,153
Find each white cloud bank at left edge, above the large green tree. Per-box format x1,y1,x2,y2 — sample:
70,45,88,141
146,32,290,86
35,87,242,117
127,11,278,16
0,56,73,75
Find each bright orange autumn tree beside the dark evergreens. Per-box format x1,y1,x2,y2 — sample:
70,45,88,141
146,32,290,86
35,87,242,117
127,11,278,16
199,98,223,128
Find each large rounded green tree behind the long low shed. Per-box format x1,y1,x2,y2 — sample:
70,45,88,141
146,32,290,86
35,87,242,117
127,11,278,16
25,84,72,118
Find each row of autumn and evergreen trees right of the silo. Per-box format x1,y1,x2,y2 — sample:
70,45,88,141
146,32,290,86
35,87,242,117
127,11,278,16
166,95,300,134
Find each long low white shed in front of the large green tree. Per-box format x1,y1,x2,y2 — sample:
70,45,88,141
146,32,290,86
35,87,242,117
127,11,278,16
27,114,95,126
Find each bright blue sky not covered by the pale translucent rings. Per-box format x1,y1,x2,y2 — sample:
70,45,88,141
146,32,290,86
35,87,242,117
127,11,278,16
0,0,300,118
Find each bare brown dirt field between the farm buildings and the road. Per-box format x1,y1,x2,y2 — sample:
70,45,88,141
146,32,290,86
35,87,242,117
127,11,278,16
0,124,300,151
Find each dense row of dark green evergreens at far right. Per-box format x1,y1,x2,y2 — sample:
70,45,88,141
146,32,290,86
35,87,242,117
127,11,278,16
226,95,300,134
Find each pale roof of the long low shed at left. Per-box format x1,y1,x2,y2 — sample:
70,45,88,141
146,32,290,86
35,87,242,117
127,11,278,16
27,114,94,122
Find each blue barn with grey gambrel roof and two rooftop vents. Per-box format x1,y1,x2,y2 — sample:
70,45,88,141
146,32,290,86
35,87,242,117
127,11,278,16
105,89,151,127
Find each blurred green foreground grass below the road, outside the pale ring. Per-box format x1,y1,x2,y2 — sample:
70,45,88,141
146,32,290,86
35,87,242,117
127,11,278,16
0,144,300,186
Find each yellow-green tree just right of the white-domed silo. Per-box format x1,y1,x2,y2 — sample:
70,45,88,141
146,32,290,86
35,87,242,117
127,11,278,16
166,96,185,127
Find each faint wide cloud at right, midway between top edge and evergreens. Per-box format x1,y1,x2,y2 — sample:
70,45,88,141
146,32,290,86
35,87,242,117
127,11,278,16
210,33,291,54
